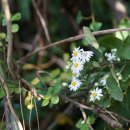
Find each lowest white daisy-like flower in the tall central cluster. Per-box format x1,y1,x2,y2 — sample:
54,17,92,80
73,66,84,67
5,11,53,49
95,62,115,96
69,78,82,91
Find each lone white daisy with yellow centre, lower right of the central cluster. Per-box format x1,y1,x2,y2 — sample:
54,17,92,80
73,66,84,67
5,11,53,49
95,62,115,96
90,87,103,102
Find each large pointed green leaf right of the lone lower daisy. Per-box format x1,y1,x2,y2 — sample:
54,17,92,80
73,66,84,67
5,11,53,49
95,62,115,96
107,73,123,101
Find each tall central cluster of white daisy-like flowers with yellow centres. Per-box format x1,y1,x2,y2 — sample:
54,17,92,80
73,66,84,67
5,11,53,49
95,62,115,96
69,47,93,91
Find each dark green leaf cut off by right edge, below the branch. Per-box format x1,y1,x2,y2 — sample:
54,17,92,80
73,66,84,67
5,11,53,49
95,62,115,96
122,36,130,60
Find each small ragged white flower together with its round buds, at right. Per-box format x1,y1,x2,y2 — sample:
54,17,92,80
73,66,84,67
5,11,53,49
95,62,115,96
105,48,120,63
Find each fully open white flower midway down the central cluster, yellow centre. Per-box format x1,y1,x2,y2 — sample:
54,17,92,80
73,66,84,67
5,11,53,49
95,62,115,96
71,61,83,73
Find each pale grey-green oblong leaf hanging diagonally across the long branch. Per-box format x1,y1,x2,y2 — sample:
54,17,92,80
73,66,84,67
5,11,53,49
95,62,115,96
83,27,99,49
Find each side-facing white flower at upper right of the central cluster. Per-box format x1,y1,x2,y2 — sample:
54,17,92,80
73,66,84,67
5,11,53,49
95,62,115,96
81,51,94,63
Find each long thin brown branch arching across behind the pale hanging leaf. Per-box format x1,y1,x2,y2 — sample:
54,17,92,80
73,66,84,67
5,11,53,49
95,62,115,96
18,28,130,63
